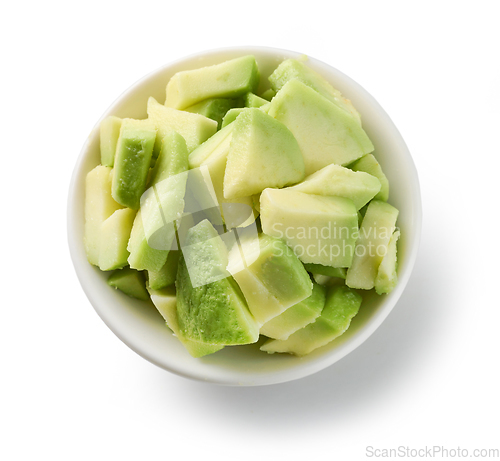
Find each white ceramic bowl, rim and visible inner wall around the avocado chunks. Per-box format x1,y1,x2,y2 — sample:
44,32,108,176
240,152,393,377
68,47,421,386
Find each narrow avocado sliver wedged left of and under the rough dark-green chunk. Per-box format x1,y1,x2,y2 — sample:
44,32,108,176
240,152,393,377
147,285,224,358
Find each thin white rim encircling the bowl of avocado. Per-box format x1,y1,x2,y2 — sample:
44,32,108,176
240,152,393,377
67,46,422,386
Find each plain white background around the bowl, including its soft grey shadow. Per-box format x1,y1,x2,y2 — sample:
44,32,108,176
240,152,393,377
0,0,500,461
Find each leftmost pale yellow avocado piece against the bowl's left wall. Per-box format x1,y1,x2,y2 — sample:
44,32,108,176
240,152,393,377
83,165,122,266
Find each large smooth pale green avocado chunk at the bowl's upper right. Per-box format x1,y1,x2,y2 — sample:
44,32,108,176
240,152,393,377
268,80,374,176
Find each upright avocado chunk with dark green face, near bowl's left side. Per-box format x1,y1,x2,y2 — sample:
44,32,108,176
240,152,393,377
111,118,156,210
